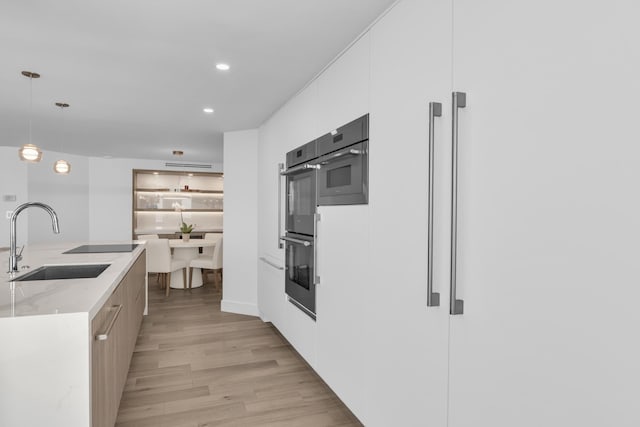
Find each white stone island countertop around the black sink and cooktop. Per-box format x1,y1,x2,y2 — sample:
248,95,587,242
0,241,144,319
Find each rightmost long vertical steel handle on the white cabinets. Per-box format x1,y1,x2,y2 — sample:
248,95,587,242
449,92,467,315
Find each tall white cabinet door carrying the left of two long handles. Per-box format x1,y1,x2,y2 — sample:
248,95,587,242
364,0,451,427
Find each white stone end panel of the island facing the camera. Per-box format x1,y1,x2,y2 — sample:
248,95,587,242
0,313,91,427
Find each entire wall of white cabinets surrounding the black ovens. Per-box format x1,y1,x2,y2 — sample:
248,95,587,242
259,0,640,427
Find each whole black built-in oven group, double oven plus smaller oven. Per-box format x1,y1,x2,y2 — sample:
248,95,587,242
280,115,369,320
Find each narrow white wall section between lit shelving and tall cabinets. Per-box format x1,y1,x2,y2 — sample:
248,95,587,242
222,130,258,316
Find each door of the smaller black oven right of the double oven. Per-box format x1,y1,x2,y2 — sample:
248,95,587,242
316,141,369,205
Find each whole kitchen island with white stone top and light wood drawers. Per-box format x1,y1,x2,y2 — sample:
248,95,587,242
0,242,147,427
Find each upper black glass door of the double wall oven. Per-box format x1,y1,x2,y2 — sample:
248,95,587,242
285,169,316,235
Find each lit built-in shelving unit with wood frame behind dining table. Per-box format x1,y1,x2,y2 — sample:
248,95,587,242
132,169,224,239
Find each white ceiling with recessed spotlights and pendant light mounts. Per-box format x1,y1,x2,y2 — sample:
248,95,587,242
0,0,395,163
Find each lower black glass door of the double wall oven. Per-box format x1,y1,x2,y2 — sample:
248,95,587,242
284,233,316,314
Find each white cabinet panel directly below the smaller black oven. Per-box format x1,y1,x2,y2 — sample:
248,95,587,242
315,205,375,420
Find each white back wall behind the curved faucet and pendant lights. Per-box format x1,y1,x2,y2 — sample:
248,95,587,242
0,147,222,247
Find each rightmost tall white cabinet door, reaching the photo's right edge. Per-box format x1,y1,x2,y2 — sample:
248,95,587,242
449,0,640,427
